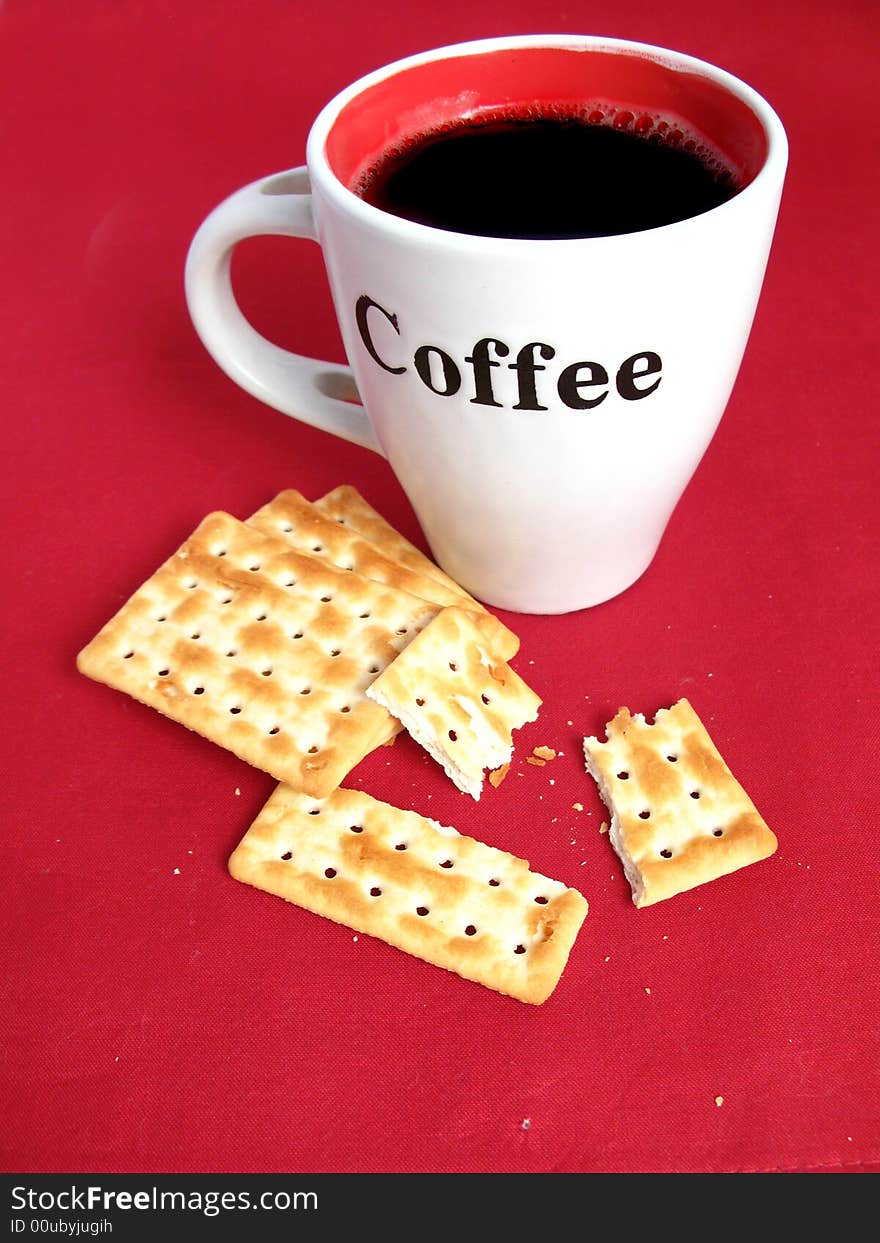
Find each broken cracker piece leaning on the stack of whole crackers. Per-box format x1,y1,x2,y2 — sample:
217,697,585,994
367,608,541,799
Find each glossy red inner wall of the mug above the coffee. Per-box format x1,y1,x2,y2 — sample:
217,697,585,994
326,46,768,191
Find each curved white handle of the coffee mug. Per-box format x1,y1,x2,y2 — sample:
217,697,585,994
185,167,384,456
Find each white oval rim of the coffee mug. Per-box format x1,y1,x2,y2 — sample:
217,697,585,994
306,34,788,252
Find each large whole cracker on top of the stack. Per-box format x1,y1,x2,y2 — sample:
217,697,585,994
77,513,447,796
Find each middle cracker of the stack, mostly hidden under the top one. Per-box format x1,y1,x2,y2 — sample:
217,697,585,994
247,488,520,660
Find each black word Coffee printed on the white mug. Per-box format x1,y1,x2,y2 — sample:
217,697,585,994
354,293,662,410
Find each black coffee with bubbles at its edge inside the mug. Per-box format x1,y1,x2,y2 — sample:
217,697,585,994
354,111,738,239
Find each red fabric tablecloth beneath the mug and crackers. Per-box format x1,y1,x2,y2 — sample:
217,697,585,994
0,0,880,1172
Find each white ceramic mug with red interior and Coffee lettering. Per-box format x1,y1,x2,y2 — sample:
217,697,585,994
186,35,787,614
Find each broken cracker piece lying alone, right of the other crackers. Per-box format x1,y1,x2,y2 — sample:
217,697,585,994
584,699,777,906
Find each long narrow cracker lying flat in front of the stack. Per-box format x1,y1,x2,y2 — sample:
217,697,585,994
229,786,587,1006
